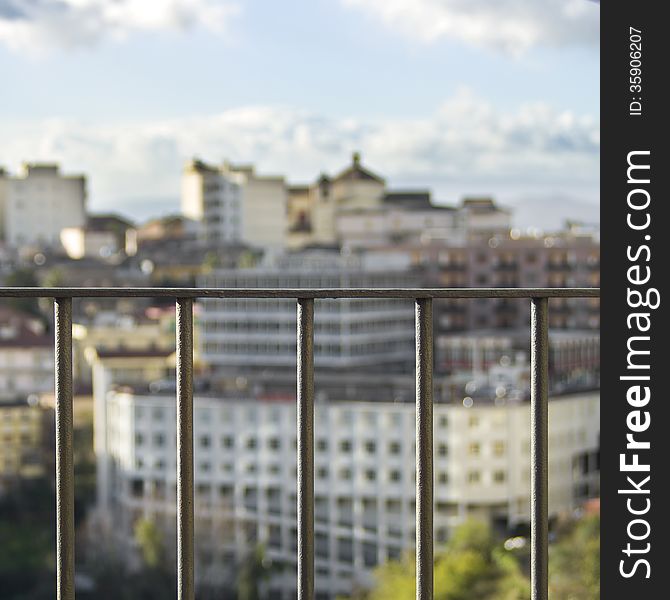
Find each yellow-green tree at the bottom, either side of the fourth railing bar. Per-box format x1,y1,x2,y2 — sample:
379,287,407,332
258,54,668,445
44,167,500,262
368,520,530,600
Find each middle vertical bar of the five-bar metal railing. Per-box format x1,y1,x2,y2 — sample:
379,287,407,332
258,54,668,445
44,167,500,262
297,298,314,600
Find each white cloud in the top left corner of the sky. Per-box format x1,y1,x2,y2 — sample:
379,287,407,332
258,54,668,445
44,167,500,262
0,0,238,53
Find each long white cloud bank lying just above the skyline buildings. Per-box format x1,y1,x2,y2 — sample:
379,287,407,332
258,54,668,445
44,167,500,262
0,90,599,218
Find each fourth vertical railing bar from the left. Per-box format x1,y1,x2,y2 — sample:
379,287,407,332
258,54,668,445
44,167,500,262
416,298,433,600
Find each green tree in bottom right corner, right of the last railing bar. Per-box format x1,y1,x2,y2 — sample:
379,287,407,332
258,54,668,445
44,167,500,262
549,515,600,600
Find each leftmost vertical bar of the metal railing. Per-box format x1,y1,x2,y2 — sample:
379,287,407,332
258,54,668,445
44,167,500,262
54,298,74,600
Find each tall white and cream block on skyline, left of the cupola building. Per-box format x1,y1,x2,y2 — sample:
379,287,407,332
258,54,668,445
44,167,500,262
181,160,288,249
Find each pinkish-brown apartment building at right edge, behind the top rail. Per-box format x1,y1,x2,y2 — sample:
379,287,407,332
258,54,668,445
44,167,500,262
367,227,600,334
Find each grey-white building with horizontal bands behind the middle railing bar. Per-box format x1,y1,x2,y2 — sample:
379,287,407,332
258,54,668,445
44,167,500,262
199,251,417,369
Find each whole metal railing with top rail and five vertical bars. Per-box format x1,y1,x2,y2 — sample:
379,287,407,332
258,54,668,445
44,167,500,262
0,288,600,600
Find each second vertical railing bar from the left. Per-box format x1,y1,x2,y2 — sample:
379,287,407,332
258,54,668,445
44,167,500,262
176,298,195,600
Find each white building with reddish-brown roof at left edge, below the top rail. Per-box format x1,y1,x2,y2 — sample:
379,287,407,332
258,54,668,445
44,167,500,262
0,307,54,402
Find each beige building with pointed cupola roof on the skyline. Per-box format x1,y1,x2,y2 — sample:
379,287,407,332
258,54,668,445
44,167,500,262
288,153,512,251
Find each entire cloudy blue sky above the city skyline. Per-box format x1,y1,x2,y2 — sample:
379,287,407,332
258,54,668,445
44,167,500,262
0,0,599,228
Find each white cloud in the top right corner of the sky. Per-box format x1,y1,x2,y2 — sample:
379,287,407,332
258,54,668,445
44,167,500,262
342,0,600,55
